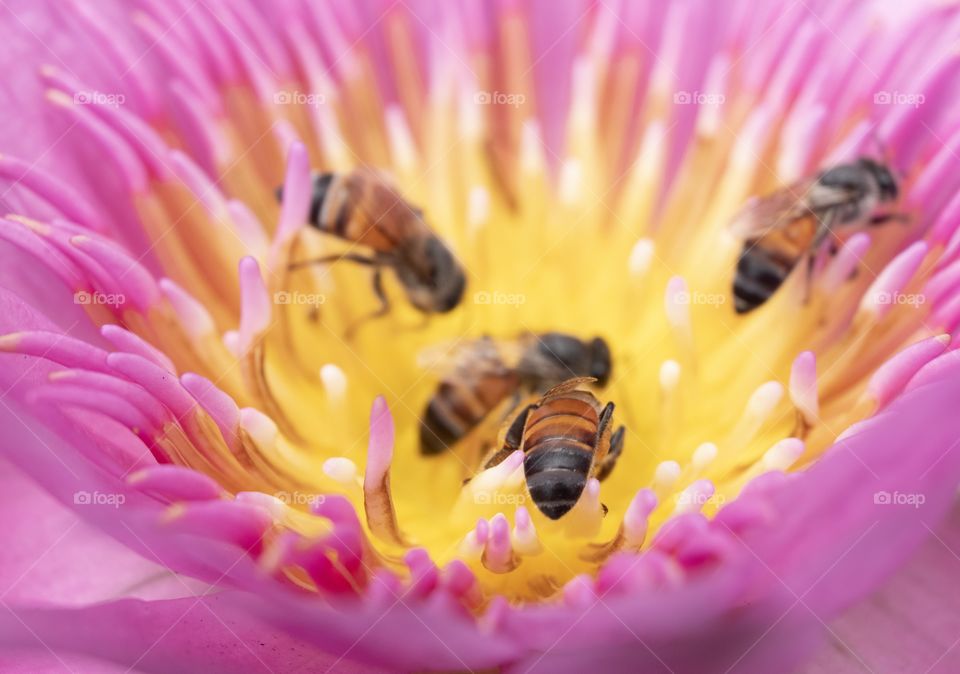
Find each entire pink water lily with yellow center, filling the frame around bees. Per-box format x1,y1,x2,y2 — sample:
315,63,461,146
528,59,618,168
0,0,960,672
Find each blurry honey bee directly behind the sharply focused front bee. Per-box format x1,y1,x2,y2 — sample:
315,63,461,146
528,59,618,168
420,332,611,458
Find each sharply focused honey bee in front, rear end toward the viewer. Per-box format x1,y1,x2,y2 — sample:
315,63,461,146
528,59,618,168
484,377,625,520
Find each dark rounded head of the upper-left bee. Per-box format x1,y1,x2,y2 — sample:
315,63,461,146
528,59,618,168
397,236,467,314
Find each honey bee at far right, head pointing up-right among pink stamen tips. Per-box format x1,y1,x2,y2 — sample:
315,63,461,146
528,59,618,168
731,158,905,314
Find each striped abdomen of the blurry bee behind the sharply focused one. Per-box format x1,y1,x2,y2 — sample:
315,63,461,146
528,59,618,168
420,369,520,454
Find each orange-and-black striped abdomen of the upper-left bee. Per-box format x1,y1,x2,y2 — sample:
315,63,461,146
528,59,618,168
310,173,411,253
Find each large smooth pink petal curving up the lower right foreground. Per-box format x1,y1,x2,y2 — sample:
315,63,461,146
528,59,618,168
492,365,960,672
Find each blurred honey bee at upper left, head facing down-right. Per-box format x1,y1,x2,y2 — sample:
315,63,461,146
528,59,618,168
278,169,466,328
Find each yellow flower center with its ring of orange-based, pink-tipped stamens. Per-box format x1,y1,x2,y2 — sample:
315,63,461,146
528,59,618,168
16,6,936,600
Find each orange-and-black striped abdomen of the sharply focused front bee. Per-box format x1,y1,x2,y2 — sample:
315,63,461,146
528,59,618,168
523,396,599,520
